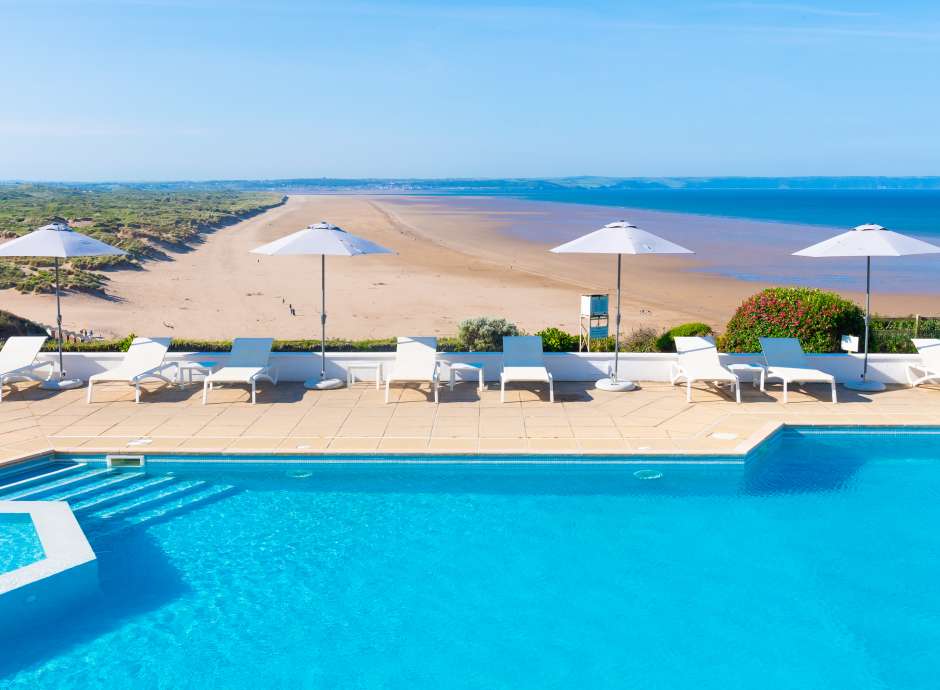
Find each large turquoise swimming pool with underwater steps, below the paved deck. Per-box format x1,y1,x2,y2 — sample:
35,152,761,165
0,429,940,690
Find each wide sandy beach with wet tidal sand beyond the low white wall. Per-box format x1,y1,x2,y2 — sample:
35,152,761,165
2,195,940,338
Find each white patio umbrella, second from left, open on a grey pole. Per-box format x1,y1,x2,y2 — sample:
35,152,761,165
251,221,394,390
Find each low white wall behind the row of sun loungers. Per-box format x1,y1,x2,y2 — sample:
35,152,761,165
41,352,920,383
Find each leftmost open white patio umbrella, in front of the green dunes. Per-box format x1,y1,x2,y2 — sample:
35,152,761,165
0,223,127,390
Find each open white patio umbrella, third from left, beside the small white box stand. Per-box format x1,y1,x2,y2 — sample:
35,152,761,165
551,220,695,391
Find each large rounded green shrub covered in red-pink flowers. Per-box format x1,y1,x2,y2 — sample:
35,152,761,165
720,288,865,352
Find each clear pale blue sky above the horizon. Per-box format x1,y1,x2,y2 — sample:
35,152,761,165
0,0,940,180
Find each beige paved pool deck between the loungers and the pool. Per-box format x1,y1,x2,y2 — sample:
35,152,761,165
0,382,940,464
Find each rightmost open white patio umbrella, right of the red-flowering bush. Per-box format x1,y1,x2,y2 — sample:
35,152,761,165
793,225,940,391
